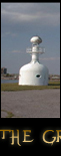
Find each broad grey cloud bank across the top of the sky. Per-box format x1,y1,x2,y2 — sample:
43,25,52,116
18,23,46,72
1,3,60,26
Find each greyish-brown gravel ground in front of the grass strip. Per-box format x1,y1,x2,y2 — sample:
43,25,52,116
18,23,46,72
1,89,60,118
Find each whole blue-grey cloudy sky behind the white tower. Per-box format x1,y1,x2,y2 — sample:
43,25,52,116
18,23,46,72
1,2,60,75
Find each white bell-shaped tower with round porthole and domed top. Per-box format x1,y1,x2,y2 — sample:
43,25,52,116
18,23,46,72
19,36,49,86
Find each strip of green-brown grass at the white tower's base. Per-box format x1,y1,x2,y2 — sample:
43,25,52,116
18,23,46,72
1,81,60,91
